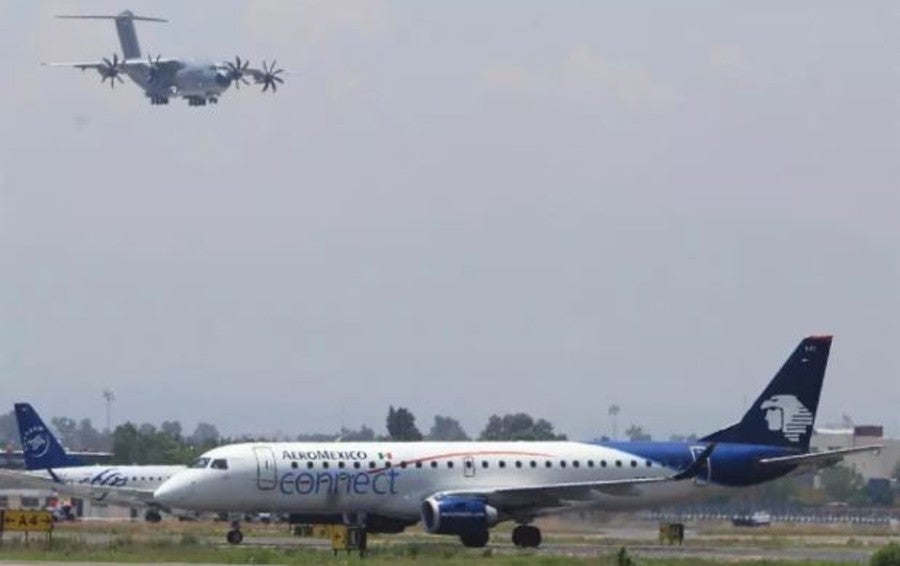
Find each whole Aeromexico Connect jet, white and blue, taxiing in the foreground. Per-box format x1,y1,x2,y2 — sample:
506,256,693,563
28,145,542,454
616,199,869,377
156,336,878,547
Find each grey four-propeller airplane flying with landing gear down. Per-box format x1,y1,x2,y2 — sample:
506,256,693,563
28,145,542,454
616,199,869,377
47,10,284,106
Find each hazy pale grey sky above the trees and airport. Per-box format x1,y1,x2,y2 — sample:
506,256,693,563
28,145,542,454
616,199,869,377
0,0,900,438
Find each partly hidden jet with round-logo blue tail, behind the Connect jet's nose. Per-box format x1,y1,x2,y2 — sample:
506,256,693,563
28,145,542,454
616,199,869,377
0,403,185,522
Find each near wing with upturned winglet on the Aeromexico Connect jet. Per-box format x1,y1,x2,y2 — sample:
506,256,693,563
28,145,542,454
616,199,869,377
435,443,716,509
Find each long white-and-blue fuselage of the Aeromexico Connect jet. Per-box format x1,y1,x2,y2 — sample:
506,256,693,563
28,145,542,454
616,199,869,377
156,442,794,522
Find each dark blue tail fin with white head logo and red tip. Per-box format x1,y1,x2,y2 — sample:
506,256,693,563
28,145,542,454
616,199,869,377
703,336,831,451
